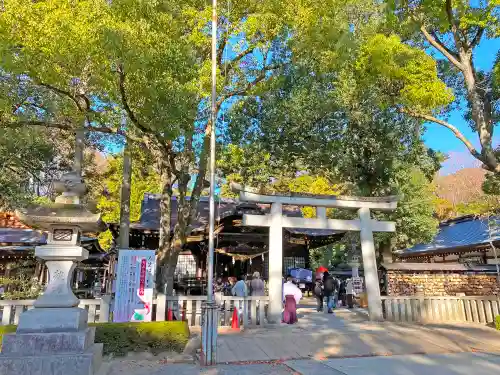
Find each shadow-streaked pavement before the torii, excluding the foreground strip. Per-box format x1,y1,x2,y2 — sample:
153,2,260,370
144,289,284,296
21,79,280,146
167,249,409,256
217,306,500,363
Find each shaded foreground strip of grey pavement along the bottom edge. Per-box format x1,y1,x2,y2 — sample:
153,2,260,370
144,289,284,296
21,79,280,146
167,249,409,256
102,353,500,375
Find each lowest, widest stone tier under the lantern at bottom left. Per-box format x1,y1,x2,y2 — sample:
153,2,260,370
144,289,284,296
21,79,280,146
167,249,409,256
0,344,102,375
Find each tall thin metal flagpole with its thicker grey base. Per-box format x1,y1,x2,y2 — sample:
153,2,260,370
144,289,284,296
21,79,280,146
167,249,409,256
201,0,219,366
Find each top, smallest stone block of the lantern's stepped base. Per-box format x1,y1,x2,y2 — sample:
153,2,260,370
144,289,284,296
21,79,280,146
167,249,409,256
17,307,88,333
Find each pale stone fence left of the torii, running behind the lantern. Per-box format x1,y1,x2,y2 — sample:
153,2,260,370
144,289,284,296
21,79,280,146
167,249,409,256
0,294,269,327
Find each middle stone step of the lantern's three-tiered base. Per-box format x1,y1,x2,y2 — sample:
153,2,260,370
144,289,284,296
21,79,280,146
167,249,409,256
2,327,95,357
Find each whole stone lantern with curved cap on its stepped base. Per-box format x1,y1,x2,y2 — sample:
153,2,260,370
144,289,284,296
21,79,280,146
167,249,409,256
0,172,106,375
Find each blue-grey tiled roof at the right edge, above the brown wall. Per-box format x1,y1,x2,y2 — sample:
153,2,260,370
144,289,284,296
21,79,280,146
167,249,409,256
398,216,500,257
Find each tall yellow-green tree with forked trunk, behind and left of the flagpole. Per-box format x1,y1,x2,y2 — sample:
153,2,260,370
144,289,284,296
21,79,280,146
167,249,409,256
0,0,286,292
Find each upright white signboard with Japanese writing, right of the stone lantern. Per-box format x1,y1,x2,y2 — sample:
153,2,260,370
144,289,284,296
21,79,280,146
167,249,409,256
113,250,156,323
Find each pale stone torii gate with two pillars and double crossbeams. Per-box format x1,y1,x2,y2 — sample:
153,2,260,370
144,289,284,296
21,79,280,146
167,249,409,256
233,184,397,323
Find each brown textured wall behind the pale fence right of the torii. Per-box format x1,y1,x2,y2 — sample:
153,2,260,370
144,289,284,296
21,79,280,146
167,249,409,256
387,271,500,296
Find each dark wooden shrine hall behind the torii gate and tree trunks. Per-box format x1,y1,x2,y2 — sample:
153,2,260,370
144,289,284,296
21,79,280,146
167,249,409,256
110,194,342,284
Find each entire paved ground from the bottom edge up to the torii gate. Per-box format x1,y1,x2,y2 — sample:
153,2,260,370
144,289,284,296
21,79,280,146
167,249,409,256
103,301,500,375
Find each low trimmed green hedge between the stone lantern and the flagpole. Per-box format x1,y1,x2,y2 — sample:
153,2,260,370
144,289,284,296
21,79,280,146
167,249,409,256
0,321,189,356
